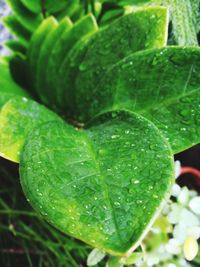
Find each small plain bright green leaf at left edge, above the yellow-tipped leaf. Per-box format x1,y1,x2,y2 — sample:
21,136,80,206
0,58,29,108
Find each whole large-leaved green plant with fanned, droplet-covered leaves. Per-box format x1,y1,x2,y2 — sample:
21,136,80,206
0,1,200,264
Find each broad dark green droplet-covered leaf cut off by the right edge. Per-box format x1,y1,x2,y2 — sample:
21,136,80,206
80,47,200,153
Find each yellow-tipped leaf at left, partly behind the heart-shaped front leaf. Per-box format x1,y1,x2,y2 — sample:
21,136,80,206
0,96,62,162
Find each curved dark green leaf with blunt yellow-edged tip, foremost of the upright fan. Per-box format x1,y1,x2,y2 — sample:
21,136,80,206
55,7,168,112
